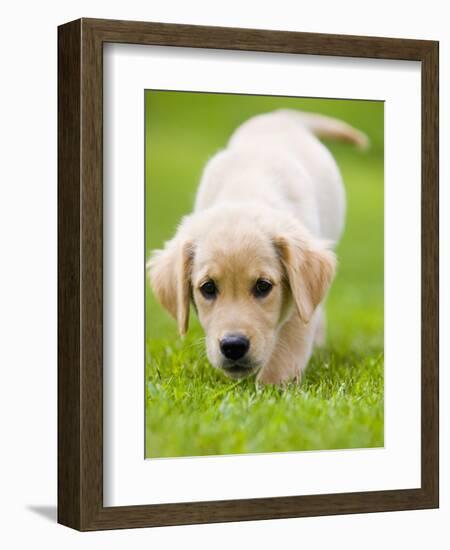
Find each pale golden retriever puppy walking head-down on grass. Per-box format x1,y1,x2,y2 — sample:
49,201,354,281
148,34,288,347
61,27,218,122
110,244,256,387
147,110,367,384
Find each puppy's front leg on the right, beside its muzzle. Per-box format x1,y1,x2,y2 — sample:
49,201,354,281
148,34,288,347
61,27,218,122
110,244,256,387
257,313,318,384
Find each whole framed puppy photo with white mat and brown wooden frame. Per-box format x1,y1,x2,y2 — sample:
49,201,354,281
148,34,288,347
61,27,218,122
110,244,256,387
58,19,439,531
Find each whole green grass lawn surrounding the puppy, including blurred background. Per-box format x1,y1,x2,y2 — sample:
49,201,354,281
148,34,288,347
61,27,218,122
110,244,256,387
146,92,384,457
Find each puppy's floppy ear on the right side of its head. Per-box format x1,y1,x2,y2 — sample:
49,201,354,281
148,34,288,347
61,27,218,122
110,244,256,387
275,234,336,323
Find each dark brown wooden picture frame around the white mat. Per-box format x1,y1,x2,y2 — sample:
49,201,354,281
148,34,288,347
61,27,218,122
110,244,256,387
58,19,439,531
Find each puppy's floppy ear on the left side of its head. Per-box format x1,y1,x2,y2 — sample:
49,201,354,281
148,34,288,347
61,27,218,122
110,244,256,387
147,237,193,336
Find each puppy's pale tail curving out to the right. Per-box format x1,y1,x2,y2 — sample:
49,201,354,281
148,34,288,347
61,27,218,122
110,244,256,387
280,109,370,150
